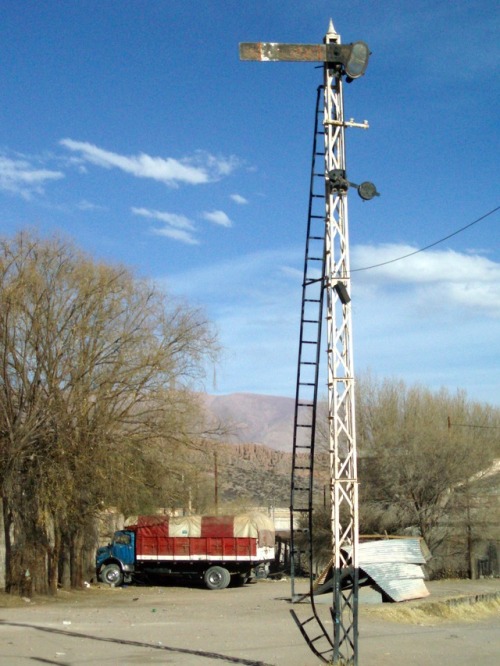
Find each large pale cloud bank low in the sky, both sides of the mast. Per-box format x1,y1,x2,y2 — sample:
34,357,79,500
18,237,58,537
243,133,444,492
166,245,500,403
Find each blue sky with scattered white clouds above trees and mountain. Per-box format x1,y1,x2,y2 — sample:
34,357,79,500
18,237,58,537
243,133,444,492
0,0,500,405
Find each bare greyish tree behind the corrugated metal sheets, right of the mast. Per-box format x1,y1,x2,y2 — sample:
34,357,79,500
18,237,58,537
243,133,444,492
357,380,500,564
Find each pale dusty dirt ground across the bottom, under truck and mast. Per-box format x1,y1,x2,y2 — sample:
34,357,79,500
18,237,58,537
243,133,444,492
0,580,500,666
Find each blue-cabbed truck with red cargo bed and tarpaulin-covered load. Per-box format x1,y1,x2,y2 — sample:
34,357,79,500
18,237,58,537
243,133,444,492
96,512,275,590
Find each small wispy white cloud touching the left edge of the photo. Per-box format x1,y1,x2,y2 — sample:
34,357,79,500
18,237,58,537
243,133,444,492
0,155,64,199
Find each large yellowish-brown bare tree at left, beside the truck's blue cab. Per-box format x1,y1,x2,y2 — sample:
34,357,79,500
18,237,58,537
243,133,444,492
0,232,217,594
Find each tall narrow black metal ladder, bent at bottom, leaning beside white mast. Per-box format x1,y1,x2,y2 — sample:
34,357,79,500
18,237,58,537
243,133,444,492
290,86,332,663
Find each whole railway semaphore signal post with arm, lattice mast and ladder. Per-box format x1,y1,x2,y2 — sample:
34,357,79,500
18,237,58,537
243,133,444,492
240,22,378,666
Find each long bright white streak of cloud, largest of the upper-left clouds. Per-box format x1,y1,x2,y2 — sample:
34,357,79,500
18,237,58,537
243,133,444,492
60,139,237,187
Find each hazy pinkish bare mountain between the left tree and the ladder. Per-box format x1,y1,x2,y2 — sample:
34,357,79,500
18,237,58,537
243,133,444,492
204,393,295,452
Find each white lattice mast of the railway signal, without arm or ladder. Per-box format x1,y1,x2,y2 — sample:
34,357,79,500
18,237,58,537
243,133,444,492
323,20,359,663
